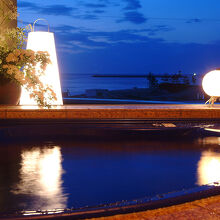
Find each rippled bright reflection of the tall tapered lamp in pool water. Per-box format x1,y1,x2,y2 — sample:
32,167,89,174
12,146,67,210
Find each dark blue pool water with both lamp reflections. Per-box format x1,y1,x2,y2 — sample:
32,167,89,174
0,137,220,213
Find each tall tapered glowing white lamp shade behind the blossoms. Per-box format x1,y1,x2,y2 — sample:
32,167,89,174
20,31,63,105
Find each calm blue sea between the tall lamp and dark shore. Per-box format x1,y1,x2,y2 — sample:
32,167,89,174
60,73,148,95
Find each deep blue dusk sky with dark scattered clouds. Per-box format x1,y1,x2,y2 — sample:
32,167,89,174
18,0,220,74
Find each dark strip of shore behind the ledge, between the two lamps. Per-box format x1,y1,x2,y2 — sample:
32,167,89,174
63,85,208,104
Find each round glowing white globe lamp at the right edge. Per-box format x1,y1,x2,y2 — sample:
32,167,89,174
202,70,220,97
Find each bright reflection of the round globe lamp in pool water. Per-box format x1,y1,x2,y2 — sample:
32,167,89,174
197,151,220,186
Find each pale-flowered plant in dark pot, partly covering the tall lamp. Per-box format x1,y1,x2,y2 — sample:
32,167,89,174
0,0,56,107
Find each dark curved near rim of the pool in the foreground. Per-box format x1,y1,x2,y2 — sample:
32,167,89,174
3,182,220,220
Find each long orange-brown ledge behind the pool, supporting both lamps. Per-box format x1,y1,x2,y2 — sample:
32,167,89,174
0,104,220,119
